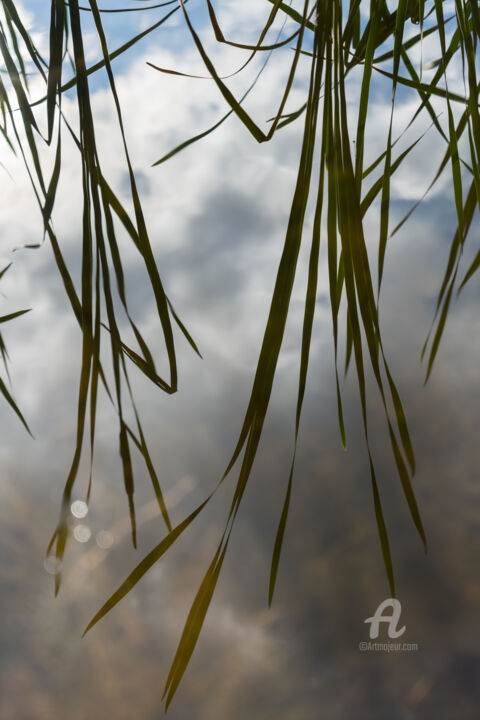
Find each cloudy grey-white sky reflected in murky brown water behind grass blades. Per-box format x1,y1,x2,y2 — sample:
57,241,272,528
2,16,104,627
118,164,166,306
0,2,480,720
